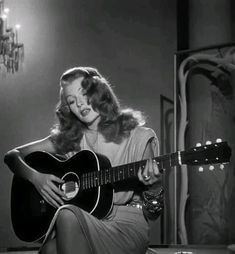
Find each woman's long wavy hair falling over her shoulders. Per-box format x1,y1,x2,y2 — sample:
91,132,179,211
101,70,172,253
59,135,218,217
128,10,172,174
51,67,145,153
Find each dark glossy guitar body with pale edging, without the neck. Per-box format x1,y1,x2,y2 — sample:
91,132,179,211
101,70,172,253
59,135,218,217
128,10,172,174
11,150,113,242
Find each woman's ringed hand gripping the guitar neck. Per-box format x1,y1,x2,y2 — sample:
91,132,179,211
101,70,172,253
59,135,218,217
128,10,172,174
138,158,161,185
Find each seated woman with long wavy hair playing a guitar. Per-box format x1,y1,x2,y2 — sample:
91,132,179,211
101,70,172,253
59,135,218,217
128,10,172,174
5,67,160,254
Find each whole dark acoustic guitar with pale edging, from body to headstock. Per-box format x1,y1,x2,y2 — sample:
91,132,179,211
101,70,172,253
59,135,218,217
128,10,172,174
11,142,231,242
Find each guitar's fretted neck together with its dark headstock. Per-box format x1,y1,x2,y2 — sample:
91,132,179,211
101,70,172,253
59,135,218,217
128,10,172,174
81,142,231,189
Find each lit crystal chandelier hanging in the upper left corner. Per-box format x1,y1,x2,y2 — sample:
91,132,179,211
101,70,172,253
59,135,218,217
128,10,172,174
0,0,24,73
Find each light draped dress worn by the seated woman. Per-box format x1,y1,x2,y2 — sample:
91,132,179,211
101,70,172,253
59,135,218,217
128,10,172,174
42,126,158,254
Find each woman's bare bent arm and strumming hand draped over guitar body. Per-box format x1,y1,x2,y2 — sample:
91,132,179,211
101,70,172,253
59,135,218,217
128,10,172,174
4,137,64,207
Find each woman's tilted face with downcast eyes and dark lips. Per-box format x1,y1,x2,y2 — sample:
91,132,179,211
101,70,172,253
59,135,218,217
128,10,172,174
63,77,100,128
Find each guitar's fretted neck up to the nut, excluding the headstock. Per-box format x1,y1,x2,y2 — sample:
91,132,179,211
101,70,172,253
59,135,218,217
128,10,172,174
81,152,181,189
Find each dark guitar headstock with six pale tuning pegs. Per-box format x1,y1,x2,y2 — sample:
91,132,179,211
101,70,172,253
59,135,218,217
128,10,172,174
181,139,231,171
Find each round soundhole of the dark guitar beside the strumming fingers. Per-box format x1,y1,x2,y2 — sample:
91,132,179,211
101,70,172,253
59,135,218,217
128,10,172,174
60,172,80,201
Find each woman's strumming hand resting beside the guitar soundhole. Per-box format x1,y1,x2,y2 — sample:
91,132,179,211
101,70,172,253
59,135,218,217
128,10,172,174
32,172,66,208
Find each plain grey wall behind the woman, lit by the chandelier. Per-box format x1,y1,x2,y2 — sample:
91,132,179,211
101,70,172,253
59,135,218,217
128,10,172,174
0,0,176,247
